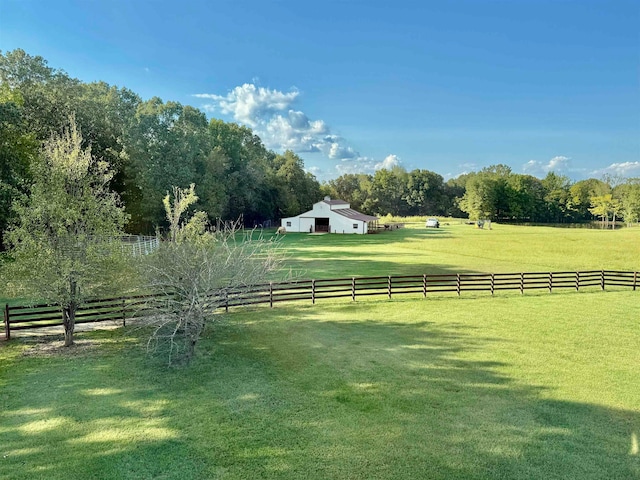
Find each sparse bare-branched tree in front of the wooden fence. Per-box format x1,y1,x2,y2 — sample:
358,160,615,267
142,188,281,364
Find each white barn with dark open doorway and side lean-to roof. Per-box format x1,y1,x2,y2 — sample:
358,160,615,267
281,197,379,235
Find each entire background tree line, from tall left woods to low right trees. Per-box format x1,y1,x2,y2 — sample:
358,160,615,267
0,49,640,251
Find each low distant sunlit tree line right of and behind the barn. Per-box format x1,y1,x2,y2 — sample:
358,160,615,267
323,165,640,226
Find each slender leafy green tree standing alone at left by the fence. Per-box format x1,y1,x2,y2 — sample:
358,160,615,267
8,120,130,346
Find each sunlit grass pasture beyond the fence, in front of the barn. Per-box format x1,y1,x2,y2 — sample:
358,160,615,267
276,223,640,278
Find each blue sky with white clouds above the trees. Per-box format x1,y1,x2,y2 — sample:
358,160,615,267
0,0,640,180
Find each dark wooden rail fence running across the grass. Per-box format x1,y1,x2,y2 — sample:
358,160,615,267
4,270,639,340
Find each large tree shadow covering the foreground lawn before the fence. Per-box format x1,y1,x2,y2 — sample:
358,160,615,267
0,308,640,479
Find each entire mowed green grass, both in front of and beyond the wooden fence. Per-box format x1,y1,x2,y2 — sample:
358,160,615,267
0,225,640,479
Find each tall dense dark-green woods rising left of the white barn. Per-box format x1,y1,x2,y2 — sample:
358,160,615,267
0,49,322,248
